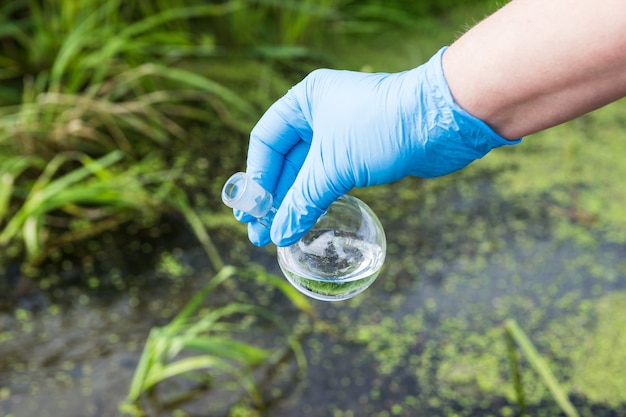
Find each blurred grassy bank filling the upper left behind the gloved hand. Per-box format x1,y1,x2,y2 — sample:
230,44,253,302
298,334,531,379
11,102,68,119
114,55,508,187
0,0,488,282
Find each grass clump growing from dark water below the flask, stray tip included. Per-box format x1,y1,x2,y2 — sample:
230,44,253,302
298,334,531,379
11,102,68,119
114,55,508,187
121,266,310,415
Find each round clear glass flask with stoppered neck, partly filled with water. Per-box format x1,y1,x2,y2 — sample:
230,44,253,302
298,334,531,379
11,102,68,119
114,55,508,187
222,172,386,301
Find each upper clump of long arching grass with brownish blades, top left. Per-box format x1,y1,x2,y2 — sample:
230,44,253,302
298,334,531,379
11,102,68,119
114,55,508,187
0,1,254,153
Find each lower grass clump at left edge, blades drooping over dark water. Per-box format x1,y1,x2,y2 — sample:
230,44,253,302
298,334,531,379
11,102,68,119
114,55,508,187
0,146,223,270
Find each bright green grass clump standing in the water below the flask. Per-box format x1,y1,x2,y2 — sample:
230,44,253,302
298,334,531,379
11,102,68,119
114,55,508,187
127,266,303,403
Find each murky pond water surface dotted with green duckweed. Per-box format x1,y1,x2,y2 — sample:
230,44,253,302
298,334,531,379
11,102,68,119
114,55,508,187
0,170,626,417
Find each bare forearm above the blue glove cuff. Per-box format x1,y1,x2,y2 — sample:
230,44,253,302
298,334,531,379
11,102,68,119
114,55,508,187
443,0,626,139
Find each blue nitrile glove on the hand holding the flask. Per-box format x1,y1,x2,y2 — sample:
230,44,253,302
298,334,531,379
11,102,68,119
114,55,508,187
236,48,521,246
